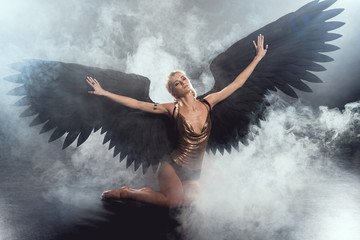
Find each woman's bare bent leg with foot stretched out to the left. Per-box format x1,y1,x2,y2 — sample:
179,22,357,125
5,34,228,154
101,162,183,208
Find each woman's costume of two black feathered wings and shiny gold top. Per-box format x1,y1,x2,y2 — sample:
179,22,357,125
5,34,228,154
6,0,344,179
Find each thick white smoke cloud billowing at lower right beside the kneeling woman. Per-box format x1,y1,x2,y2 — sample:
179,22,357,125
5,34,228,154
182,96,360,240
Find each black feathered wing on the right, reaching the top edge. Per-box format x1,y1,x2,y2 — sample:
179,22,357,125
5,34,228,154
200,0,344,153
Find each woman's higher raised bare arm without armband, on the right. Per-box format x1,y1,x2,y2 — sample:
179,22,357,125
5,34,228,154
205,34,268,107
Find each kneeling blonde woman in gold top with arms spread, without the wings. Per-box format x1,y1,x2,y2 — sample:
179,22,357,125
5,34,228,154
86,34,268,208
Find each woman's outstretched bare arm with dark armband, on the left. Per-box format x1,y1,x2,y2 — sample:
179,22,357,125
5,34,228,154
86,77,173,115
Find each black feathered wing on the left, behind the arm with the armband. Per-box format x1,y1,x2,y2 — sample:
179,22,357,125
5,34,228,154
5,60,173,173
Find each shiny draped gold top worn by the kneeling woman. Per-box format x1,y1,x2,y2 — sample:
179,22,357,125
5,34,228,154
171,100,211,170
